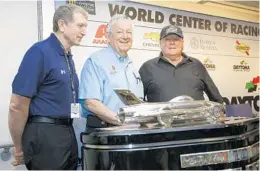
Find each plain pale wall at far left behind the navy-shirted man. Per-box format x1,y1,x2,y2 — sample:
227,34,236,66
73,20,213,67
0,1,38,169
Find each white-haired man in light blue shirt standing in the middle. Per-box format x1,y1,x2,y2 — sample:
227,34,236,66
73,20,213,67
79,15,143,128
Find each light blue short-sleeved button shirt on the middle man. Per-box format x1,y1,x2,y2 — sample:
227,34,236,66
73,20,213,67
79,46,143,117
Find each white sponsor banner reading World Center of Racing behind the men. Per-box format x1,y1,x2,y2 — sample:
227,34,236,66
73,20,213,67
43,0,259,111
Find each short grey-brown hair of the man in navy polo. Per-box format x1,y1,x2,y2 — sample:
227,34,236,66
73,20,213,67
53,4,88,32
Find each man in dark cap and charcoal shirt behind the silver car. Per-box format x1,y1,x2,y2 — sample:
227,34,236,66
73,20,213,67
139,25,223,103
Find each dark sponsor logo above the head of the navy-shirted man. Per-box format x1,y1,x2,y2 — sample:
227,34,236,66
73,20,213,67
67,0,96,15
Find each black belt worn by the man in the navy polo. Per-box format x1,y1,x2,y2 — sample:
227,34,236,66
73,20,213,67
28,116,73,125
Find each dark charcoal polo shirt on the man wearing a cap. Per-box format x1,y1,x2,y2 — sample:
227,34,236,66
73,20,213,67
139,53,223,103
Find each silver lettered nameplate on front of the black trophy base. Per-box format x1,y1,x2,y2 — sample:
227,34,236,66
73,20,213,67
180,142,259,168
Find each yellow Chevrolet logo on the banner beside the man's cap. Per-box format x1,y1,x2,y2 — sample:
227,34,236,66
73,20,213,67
143,32,160,47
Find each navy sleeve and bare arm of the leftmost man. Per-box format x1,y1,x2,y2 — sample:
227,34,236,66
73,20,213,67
8,44,45,166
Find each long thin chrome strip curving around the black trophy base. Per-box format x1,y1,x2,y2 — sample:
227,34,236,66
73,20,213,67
83,129,259,151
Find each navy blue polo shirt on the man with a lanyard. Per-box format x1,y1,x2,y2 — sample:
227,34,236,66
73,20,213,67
12,34,79,118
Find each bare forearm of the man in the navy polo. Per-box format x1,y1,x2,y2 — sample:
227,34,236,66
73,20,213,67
8,94,31,152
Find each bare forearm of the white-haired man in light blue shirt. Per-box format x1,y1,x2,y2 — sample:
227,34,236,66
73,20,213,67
84,99,120,125
